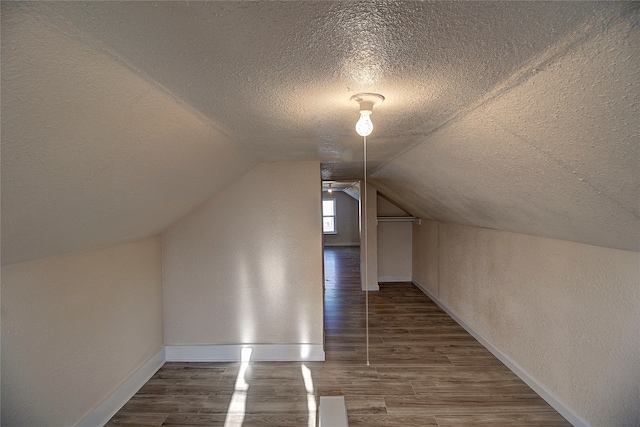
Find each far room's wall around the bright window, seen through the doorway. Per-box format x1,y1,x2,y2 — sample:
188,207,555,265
322,191,360,246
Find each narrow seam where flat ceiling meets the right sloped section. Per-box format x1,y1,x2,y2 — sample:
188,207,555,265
370,4,640,175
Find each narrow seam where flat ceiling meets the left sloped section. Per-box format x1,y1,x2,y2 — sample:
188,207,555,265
21,3,240,148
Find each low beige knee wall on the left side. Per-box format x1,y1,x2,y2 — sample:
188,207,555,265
2,237,163,426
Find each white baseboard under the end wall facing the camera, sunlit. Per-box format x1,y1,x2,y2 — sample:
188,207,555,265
165,344,324,362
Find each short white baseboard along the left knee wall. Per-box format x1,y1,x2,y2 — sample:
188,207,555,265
75,347,165,427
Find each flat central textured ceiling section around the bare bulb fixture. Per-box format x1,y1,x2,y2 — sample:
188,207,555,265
18,2,608,179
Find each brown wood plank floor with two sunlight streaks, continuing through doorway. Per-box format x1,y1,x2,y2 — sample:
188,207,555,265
107,248,570,427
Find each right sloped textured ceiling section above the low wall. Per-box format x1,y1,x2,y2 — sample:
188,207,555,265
371,6,640,251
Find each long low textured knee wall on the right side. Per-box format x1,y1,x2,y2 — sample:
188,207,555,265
413,221,640,426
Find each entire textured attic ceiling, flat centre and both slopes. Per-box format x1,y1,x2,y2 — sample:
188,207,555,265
1,1,640,264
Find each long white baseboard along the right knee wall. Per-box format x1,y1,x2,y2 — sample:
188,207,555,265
413,279,591,427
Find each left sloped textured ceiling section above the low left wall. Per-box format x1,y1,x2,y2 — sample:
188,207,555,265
2,2,257,264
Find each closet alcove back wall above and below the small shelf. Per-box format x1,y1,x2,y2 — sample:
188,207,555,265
377,195,412,282
